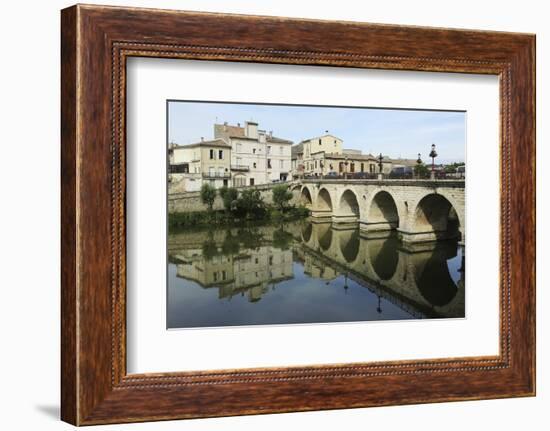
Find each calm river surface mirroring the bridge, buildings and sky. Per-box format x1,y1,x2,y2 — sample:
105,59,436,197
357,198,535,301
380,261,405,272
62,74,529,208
167,221,465,328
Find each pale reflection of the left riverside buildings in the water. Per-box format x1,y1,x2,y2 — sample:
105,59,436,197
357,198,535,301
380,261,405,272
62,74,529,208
171,244,293,302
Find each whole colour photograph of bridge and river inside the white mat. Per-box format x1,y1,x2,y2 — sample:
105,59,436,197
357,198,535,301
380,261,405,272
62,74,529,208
167,100,466,329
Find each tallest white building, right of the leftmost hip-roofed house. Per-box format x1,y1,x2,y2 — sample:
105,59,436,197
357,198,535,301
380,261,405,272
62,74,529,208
214,121,293,187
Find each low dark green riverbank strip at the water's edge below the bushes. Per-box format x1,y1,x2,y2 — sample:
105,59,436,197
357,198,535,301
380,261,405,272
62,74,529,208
168,206,310,230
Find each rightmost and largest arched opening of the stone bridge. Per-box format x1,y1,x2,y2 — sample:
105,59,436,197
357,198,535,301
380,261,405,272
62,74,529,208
412,193,460,239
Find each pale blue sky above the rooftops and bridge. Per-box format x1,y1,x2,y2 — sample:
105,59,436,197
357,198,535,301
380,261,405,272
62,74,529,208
168,101,466,163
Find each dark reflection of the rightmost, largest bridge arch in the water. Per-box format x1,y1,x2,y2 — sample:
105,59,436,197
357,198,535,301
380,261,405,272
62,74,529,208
415,242,458,307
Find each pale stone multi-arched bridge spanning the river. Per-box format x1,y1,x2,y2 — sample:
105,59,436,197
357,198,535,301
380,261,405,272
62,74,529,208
290,179,465,244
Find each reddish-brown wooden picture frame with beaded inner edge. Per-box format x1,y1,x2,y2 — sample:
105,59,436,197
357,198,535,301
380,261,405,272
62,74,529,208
61,5,535,425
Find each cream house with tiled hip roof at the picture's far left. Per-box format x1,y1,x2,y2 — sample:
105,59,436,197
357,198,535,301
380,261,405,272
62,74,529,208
168,139,231,191
